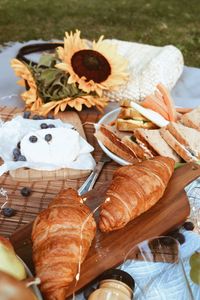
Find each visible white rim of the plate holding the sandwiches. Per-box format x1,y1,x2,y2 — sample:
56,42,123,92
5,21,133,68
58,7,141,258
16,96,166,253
97,107,130,166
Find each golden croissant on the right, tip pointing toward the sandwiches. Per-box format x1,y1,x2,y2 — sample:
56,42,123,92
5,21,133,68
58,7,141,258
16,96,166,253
99,156,175,232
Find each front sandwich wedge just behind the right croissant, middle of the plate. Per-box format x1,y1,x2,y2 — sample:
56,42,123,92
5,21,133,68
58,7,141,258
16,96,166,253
134,128,181,162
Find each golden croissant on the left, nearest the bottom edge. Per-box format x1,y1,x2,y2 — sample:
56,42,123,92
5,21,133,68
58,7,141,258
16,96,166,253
32,189,96,300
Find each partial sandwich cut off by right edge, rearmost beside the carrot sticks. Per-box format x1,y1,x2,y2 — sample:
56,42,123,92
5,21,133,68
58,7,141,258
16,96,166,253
180,106,200,131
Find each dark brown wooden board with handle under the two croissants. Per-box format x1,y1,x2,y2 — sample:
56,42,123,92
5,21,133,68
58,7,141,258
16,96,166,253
10,163,200,296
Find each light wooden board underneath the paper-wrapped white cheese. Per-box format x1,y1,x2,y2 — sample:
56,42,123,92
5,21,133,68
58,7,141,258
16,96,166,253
0,107,91,181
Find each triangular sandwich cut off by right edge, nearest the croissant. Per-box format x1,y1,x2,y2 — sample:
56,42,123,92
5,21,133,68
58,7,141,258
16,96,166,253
160,122,200,162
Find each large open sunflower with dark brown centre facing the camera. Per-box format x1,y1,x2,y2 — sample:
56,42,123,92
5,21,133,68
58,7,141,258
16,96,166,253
56,30,128,96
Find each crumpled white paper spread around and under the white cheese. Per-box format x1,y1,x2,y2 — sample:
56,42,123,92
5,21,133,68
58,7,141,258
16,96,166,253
0,116,95,176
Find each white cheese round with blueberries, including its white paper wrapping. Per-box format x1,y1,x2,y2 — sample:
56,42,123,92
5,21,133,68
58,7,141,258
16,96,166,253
0,115,95,175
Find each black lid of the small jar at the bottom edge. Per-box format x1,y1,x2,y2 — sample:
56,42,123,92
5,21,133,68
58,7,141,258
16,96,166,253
99,269,135,290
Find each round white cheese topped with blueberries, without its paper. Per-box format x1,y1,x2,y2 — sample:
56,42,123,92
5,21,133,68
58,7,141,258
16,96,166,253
14,123,94,167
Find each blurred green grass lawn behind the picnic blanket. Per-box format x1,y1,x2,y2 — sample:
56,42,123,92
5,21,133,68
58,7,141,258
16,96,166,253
0,0,200,67
